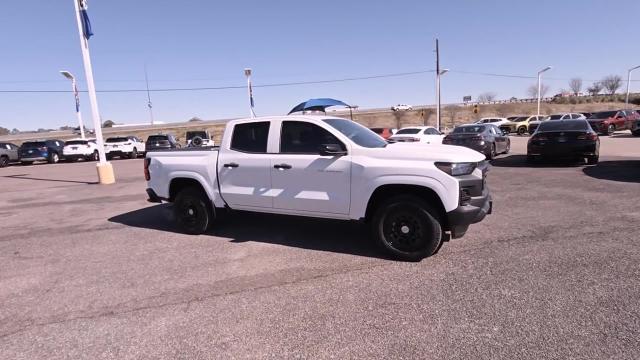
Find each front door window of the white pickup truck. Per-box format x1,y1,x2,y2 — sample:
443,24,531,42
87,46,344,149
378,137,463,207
280,121,346,154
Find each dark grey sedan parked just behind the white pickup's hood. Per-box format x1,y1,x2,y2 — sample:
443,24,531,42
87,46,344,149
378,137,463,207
442,124,511,160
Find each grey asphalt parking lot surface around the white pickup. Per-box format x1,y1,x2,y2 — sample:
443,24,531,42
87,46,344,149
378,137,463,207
0,134,640,359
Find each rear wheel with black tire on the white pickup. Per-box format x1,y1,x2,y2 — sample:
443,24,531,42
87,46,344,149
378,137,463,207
173,187,213,235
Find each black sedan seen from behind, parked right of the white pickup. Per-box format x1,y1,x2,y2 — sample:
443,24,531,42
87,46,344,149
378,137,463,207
527,119,600,164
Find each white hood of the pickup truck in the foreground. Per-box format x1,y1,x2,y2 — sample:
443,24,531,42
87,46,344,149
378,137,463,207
363,143,485,162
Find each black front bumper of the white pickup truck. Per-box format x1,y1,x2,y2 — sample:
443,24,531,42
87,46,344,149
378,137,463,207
447,172,493,239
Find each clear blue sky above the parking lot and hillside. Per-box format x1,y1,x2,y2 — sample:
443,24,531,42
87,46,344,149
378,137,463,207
0,0,640,130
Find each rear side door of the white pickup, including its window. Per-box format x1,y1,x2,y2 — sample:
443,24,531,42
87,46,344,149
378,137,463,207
218,121,273,209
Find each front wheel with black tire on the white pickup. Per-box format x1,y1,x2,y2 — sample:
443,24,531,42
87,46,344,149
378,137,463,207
371,195,442,261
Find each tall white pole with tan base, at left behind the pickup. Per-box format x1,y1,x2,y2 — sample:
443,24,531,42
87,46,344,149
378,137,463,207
72,0,115,185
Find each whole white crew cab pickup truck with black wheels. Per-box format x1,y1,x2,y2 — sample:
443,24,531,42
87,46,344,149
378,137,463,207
144,115,492,261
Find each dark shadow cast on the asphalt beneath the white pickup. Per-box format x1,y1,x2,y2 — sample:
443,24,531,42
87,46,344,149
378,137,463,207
109,204,386,259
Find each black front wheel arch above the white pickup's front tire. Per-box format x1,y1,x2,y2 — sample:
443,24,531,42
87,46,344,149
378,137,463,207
365,184,447,228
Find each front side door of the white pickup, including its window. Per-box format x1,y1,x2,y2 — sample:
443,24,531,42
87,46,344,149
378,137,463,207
271,120,351,214
